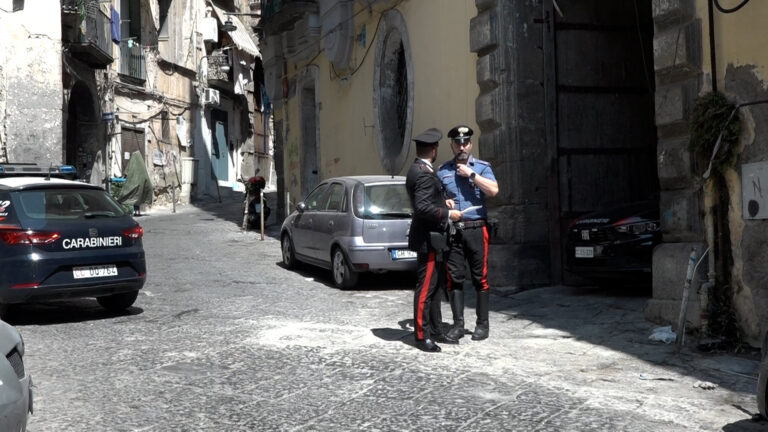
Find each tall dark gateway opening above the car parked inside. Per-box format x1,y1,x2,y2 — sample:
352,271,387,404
542,0,659,282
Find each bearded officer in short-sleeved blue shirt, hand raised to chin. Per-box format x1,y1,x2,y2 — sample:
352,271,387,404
437,125,499,340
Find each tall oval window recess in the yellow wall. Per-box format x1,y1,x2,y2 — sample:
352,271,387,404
373,10,413,175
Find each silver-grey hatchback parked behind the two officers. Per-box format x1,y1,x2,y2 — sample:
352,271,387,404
280,175,416,288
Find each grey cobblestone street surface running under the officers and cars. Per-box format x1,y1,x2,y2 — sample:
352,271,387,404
9,198,767,432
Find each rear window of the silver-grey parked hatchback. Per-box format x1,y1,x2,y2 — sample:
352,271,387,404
355,183,413,219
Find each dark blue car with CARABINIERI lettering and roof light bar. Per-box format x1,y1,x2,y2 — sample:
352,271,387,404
0,164,147,313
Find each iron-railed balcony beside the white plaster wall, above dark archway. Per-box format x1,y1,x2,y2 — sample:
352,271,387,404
61,0,114,69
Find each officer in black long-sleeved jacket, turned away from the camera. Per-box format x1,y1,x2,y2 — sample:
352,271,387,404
405,128,461,352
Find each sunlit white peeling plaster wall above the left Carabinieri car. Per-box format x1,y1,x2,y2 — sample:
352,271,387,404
0,0,63,164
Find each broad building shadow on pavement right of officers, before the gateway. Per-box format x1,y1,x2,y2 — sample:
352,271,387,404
480,286,759,393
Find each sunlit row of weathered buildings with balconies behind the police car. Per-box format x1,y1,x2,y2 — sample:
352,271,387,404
0,0,274,208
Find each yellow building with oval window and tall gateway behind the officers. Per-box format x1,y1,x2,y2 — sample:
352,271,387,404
263,0,766,344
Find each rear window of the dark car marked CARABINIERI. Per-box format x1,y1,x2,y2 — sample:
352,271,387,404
11,188,126,220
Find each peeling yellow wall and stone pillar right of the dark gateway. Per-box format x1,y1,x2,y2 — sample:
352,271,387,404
646,0,768,346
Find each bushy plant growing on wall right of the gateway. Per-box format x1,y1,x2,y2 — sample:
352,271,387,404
689,92,741,175
